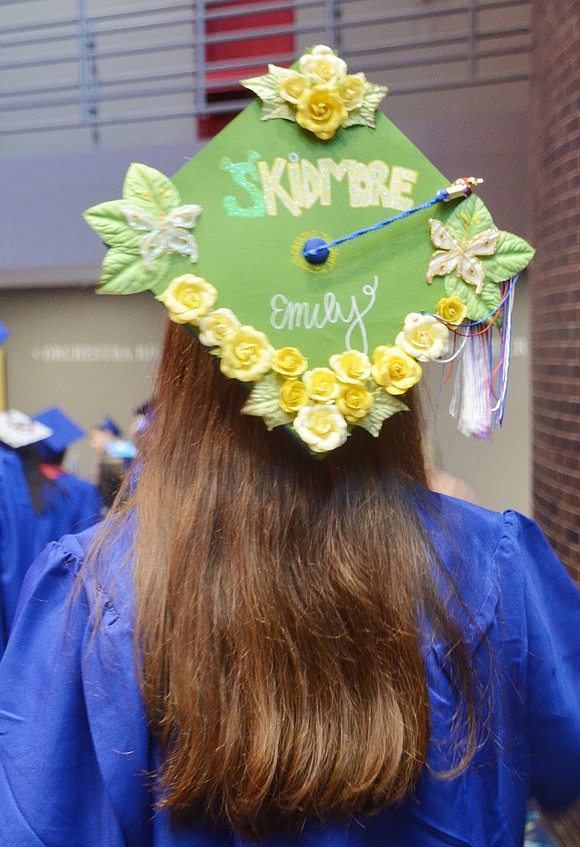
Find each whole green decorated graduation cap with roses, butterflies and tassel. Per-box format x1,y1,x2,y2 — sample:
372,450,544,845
85,45,533,454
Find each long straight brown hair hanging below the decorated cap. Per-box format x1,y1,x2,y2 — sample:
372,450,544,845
98,324,475,839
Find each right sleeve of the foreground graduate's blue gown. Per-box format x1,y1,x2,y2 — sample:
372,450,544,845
508,516,580,809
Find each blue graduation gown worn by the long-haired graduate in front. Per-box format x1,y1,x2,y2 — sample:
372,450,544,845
0,498,580,847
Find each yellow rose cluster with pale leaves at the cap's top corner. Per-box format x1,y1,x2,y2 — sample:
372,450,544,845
242,44,387,141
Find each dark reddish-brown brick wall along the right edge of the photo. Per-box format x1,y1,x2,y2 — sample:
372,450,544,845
530,0,580,582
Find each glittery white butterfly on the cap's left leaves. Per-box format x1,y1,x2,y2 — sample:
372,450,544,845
121,204,201,271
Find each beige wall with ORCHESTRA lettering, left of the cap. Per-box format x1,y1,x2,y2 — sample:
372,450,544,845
0,288,165,478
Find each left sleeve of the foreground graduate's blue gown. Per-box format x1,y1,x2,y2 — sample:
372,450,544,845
0,539,126,847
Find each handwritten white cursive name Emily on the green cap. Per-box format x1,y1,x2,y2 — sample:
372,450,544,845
270,276,379,354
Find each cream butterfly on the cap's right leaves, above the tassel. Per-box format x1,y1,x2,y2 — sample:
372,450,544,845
427,218,501,294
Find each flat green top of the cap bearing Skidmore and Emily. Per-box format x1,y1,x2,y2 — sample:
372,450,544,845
165,102,455,367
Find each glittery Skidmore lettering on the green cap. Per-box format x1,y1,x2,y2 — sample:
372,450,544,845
220,150,418,218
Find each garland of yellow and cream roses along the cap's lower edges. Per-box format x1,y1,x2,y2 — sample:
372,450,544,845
157,274,466,453
